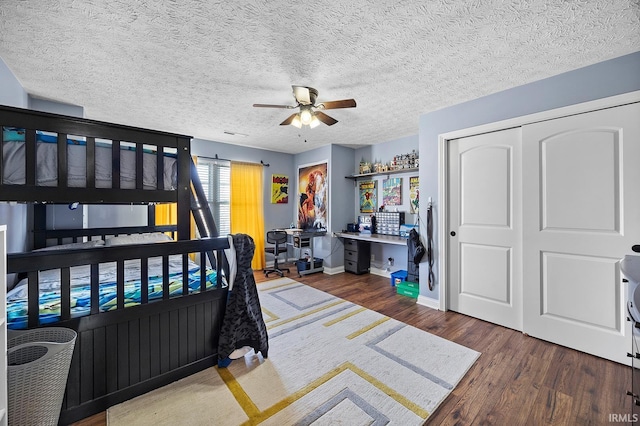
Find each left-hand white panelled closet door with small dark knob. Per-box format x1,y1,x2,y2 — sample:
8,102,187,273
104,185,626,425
447,128,522,330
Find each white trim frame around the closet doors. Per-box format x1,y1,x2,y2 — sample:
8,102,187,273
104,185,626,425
438,90,640,311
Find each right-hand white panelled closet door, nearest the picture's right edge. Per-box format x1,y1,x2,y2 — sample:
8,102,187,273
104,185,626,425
522,103,640,364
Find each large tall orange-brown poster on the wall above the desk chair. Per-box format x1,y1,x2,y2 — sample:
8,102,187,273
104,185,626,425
298,162,329,231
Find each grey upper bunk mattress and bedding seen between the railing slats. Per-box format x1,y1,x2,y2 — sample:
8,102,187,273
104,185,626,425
2,127,177,190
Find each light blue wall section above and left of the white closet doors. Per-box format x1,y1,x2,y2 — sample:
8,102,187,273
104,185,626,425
419,52,640,299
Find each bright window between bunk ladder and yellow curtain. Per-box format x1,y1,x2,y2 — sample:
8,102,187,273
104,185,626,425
196,157,231,236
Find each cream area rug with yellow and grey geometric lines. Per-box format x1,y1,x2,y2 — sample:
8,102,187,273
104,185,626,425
107,278,480,426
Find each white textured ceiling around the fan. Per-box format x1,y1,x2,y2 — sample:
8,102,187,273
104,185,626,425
0,0,640,153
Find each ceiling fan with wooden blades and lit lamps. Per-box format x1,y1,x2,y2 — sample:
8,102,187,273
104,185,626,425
253,86,356,129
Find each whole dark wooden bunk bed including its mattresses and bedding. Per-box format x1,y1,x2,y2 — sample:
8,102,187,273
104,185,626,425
0,106,229,424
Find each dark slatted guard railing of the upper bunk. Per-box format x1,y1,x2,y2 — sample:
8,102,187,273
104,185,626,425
0,106,191,204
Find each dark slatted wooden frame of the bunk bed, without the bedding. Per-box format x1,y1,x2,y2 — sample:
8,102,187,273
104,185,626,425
0,106,229,424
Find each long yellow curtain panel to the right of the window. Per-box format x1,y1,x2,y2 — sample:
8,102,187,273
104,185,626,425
231,162,265,270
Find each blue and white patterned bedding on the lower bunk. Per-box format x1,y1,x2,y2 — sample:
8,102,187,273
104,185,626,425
7,256,217,330
